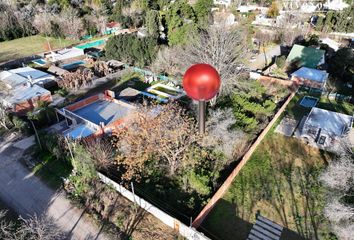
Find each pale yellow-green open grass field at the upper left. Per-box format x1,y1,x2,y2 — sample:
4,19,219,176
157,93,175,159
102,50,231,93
0,35,79,63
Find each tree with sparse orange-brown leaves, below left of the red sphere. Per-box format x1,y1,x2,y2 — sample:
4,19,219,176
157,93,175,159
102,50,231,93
114,103,197,180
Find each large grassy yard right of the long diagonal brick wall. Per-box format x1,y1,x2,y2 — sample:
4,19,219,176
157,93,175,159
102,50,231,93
202,128,330,240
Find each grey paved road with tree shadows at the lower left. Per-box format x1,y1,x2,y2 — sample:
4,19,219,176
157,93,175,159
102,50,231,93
0,139,109,240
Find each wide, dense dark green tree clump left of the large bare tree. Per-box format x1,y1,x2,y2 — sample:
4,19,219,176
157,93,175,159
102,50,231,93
106,34,157,67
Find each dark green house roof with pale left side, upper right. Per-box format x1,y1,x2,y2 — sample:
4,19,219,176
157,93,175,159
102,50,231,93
286,44,325,68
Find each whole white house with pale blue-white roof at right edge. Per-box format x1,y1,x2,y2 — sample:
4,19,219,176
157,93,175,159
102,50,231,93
300,107,354,150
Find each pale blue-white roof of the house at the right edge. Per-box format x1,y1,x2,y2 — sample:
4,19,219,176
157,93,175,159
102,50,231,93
305,107,353,136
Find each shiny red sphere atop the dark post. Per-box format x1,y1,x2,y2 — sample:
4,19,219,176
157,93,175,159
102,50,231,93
183,64,221,101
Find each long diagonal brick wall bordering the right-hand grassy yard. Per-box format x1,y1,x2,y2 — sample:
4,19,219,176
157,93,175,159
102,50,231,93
192,92,295,228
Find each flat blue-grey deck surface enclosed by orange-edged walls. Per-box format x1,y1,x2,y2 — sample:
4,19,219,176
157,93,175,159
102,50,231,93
73,99,132,125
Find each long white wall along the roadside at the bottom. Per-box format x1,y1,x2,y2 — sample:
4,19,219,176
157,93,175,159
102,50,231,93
98,173,210,240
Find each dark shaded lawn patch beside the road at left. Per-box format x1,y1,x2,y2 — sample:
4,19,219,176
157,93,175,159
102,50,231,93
33,153,72,189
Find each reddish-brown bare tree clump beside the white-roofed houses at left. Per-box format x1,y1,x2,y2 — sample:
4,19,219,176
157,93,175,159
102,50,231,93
59,68,93,91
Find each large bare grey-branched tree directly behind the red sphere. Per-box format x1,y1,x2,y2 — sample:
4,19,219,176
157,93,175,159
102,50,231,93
154,26,246,94
